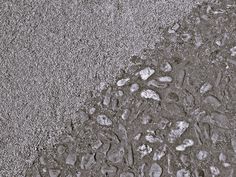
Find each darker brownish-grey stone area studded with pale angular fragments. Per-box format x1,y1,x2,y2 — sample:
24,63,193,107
26,1,236,177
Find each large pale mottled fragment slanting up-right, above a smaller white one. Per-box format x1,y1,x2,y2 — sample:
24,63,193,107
168,121,189,143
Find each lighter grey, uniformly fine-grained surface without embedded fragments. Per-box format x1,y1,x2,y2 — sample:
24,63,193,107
0,0,205,176
